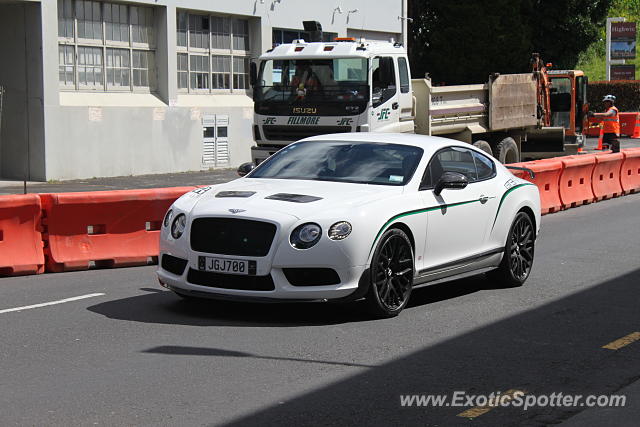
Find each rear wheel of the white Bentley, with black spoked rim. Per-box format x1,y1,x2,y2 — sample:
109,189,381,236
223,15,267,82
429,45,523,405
487,212,535,288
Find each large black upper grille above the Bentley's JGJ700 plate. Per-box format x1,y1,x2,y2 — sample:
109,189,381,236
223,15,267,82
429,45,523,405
191,218,276,257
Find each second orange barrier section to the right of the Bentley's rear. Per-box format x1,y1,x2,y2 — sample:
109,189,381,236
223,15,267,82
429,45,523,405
558,154,596,209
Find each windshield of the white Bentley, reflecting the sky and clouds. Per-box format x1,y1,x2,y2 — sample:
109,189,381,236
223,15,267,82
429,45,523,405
247,141,423,185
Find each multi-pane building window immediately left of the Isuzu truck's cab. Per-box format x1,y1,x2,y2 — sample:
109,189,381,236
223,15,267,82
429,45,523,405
176,11,254,93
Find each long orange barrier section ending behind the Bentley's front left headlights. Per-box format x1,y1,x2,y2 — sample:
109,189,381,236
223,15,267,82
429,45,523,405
40,187,193,272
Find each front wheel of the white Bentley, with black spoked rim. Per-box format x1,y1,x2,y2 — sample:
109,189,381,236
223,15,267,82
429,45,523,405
366,228,414,318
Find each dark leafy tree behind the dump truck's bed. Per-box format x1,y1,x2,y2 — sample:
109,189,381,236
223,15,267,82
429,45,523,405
409,0,611,84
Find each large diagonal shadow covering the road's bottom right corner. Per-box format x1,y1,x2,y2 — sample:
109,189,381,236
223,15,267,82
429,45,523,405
210,270,640,426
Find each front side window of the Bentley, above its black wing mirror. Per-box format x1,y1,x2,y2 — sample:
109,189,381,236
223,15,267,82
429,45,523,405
420,147,478,188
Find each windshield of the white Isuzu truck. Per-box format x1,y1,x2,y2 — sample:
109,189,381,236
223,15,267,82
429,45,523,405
255,58,369,103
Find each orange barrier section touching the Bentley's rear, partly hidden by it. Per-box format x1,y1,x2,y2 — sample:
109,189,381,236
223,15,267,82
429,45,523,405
509,159,562,215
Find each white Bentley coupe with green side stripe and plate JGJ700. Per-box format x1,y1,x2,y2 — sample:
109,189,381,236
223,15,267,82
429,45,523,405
157,133,540,317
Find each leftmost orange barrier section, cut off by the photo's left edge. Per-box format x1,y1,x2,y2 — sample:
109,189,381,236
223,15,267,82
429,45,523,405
0,194,44,276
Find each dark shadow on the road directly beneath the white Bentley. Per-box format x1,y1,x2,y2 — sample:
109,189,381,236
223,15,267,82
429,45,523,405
88,277,491,327
